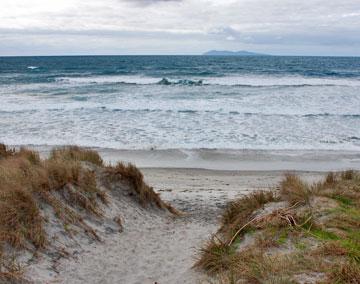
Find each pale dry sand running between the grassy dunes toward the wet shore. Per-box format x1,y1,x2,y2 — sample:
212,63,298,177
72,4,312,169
24,168,323,284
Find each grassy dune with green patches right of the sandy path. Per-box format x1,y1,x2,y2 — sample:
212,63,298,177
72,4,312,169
195,171,360,283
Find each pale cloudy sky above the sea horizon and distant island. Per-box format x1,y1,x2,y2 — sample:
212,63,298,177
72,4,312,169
0,0,360,56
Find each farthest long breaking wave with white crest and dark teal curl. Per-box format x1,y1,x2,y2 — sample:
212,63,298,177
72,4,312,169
56,75,360,87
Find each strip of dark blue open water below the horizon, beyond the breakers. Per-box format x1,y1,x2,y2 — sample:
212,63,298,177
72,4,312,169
0,56,360,83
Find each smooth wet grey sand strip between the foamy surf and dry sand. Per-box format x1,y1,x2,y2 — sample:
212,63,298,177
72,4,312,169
13,145,360,172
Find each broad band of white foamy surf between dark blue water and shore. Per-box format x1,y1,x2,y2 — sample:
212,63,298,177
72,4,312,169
0,73,360,150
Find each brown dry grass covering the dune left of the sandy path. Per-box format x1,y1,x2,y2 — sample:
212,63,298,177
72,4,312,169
0,144,178,282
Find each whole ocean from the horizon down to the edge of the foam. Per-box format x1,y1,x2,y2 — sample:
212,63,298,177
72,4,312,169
0,53,360,151
